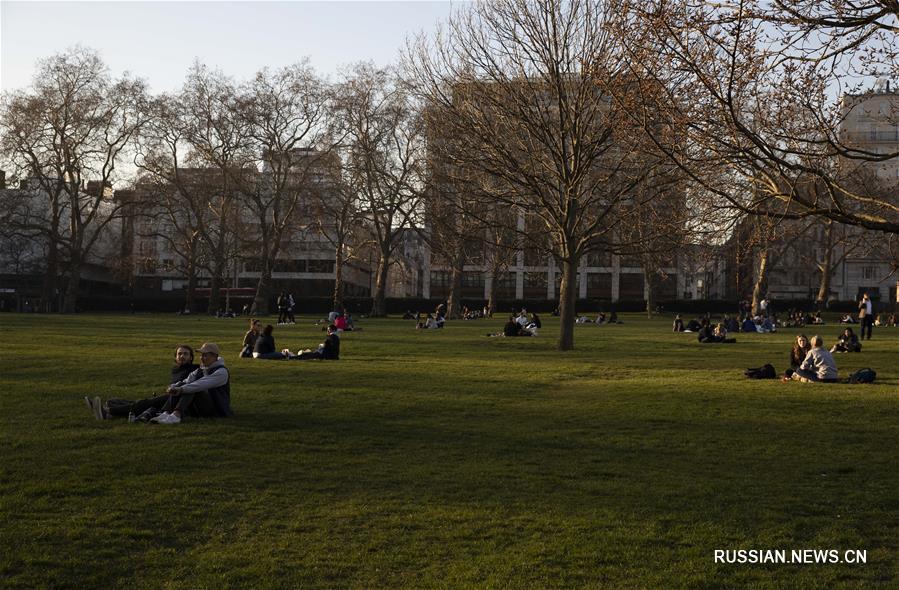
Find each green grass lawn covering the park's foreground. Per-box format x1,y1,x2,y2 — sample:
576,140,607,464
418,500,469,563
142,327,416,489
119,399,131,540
0,314,899,588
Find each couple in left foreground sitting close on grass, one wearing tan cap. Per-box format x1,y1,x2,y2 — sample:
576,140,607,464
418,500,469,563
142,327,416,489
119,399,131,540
84,342,233,424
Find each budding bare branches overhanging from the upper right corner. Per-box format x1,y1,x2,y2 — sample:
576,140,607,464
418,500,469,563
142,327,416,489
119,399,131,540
623,0,899,234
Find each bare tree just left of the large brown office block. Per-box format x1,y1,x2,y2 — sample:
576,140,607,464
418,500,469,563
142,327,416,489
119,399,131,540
335,64,425,316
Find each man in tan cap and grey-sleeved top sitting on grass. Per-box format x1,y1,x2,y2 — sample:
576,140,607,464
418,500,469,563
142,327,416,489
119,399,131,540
152,342,232,424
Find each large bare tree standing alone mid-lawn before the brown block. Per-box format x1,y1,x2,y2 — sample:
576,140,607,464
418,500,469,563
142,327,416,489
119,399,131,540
408,0,668,350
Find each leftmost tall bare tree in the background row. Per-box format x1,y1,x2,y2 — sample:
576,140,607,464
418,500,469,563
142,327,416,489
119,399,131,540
0,48,145,312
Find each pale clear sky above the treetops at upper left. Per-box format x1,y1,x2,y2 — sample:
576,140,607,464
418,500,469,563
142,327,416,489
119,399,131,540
0,0,450,92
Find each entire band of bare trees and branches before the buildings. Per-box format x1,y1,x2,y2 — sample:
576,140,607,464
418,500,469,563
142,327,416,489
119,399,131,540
0,0,899,350
